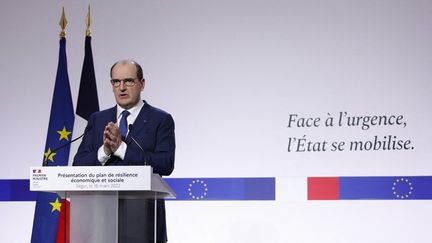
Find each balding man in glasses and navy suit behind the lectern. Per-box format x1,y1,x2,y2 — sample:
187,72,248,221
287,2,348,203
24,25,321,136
73,60,175,243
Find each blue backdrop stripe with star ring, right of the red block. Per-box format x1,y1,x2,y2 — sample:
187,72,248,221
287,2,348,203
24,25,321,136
339,176,432,200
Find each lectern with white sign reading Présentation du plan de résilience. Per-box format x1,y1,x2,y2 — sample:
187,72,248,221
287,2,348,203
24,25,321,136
30,166,176,243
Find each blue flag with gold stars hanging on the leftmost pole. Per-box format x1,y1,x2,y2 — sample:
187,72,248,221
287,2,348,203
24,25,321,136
31,37,74,243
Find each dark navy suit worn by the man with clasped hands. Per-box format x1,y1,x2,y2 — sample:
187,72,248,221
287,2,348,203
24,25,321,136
73,102,175,243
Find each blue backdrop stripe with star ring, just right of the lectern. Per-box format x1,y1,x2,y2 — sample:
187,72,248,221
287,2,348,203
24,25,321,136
165,177,276,200
